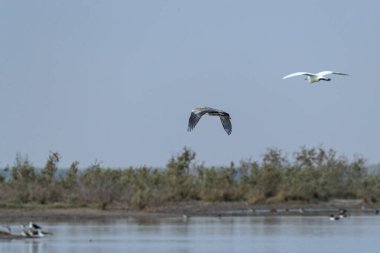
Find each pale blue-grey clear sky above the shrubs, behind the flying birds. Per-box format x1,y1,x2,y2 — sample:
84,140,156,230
0,0,380,167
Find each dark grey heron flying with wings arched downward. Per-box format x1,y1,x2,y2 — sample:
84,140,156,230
187,107,232,135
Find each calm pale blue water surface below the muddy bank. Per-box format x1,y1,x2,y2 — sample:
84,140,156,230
0,216,380,253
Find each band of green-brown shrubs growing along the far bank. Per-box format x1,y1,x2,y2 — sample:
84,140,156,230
0,147,380,209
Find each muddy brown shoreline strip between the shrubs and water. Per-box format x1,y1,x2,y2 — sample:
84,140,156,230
0,200,380,223
